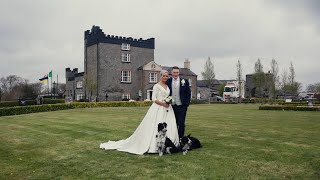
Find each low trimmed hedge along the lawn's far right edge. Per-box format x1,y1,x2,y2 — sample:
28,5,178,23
259,105,320,111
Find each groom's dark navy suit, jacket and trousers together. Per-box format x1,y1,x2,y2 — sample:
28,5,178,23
166,78,191,138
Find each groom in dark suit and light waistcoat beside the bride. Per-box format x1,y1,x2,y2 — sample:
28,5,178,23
167,66,191,138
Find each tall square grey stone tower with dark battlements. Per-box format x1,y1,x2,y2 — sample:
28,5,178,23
84,26,155,101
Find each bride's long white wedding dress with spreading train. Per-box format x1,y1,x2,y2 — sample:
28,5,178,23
100,84,179,155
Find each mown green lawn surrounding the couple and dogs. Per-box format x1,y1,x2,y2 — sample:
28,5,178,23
0,104,320,179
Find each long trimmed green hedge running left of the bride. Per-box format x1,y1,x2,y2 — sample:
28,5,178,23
0,101,152,116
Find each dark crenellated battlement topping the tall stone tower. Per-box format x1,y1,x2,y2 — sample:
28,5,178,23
84,26,155,49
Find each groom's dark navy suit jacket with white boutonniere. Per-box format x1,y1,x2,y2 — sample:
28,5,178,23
166,77,191,106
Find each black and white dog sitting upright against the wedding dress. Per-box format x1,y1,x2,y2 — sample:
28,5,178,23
156,122,179,156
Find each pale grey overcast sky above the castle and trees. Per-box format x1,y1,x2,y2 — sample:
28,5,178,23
0,0,320,89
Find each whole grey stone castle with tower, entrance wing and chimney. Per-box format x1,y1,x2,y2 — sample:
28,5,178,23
66,26,197,101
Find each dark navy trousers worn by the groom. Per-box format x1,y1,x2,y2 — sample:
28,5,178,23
172,105,188,138
